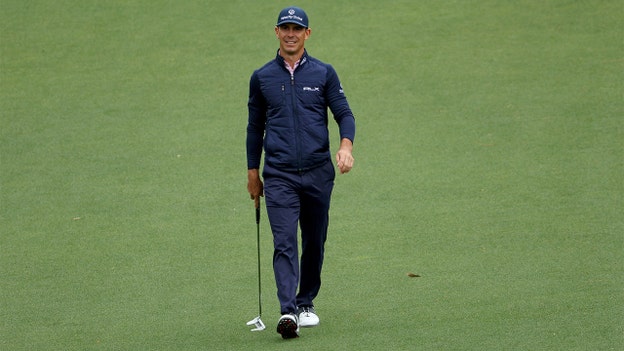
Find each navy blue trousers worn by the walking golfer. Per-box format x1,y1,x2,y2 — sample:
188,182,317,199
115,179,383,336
262,160,336,314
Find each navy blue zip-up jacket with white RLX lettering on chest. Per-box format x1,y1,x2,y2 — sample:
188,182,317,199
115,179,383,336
247,52,355,171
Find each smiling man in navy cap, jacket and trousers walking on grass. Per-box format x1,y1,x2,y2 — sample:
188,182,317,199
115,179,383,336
247,7,355,339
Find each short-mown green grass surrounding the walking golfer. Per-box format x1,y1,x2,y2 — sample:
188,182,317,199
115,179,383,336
0,0,624,350
